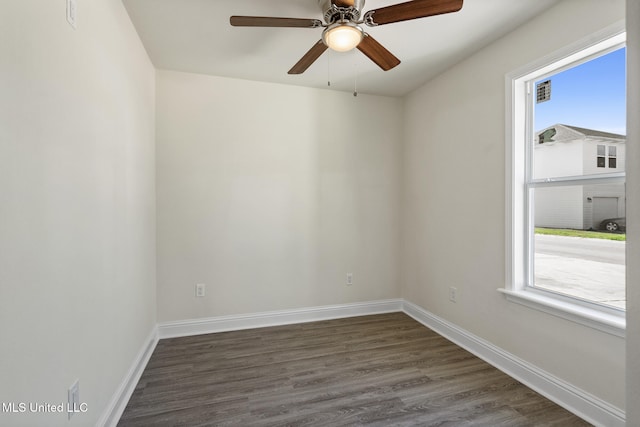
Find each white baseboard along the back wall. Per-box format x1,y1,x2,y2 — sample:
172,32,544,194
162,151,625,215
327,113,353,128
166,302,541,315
158,299,402,339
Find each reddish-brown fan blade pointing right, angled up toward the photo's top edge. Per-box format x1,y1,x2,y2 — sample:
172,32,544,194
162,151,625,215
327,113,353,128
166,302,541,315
365,0,463,26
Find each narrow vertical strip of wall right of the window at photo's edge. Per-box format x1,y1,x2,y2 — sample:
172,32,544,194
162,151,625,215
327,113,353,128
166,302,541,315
626,0,640,426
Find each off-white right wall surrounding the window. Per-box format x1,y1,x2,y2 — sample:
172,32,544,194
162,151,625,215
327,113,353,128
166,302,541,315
401,0,625,408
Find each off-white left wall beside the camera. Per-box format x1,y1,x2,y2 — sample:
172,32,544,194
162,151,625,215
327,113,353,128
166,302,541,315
0,0,155,426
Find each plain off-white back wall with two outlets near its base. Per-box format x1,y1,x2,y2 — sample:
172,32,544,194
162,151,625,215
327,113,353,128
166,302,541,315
157,71,402,321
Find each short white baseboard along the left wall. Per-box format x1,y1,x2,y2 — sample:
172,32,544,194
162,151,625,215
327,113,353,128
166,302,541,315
96,327,158,427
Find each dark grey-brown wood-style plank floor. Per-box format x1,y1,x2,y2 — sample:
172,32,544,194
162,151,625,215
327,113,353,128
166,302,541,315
118,313,588,427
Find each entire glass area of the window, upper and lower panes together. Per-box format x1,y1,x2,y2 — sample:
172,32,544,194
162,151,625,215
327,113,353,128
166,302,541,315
525,44,626,310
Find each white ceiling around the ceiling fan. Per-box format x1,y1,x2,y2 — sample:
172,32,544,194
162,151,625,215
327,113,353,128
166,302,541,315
123,0,560,96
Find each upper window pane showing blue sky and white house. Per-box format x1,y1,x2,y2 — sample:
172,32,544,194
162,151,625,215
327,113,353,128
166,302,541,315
531,48,626,179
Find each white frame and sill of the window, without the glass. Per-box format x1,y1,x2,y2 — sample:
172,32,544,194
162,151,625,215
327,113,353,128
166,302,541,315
498,22,626,337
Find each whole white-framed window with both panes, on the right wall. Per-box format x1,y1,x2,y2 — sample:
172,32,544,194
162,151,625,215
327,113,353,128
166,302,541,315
500,28,626,336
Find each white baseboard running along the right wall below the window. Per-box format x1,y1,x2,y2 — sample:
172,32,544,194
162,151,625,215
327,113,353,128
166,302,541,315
403,301,625,427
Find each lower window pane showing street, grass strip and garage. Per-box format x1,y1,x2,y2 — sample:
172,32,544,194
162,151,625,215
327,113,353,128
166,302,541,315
531,183,626,309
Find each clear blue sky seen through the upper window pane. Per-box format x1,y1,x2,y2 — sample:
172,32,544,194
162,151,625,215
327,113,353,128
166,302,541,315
535,48,626,135
